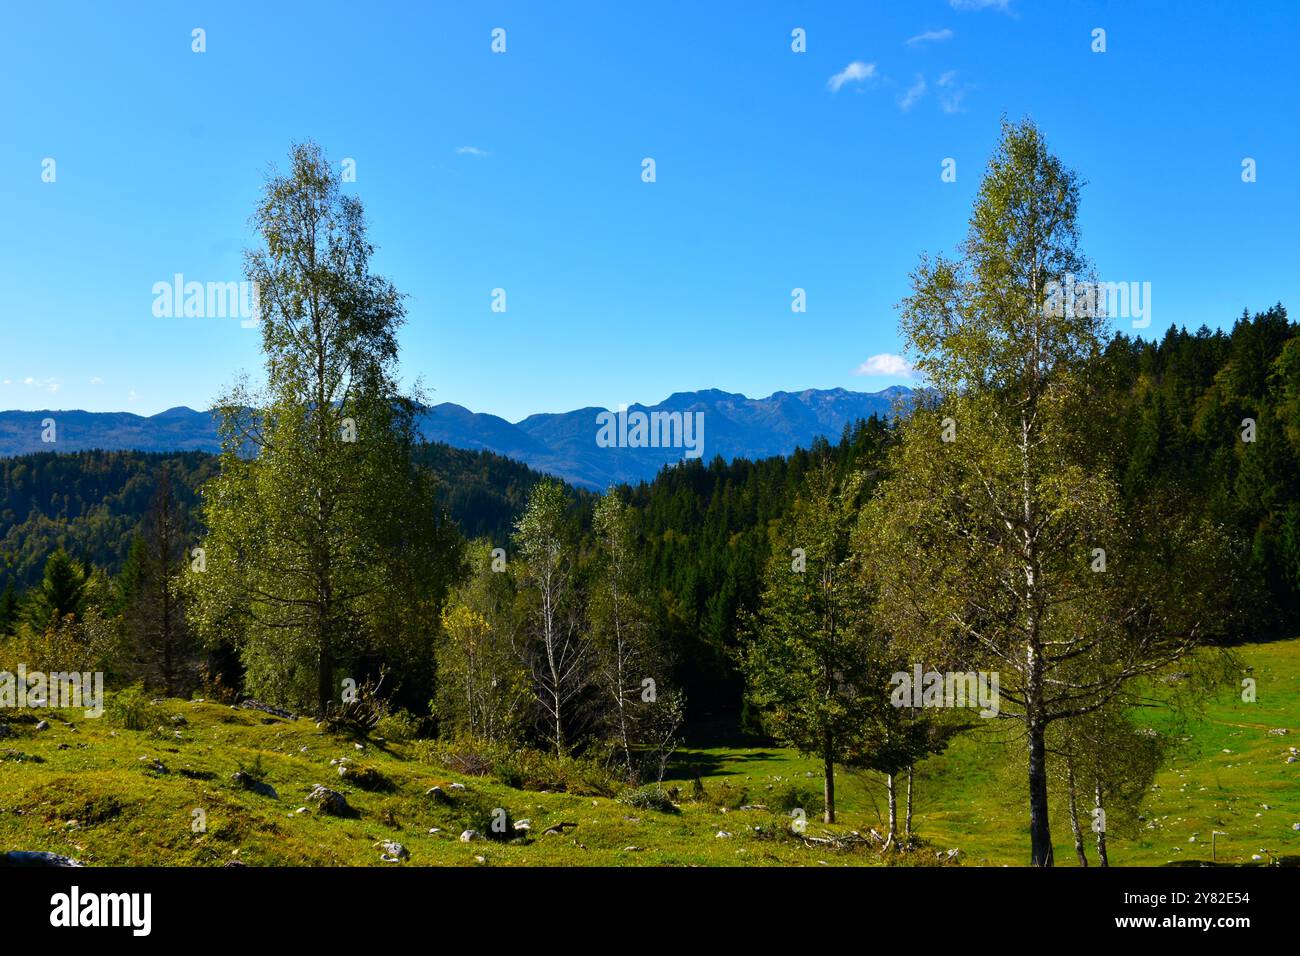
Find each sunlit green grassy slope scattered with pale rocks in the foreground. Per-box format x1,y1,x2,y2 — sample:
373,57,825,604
0,640,1300,865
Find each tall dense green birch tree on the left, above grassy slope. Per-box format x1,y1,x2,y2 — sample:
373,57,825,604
187,143,460,717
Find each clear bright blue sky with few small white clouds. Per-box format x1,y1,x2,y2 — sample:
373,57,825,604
0,0,1300,420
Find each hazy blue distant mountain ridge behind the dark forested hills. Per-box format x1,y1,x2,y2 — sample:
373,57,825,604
0,385,914,490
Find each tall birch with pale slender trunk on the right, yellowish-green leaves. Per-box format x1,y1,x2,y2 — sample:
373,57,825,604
868,121,1231,866
